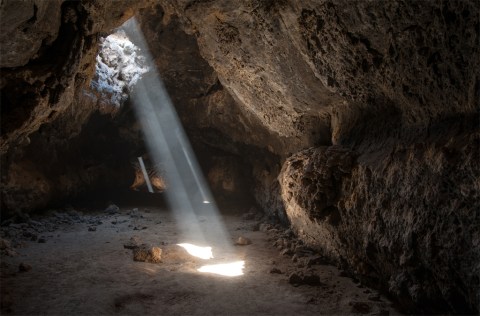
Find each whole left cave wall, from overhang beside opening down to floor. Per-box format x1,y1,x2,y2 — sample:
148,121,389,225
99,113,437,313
0,1,154,216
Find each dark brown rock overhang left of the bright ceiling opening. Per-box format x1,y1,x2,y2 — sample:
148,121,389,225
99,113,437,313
0,0,152,154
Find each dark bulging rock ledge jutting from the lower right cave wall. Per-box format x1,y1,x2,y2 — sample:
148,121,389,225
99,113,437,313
280,132,480,313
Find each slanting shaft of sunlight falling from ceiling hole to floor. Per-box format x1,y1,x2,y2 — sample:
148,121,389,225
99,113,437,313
122,18,244,276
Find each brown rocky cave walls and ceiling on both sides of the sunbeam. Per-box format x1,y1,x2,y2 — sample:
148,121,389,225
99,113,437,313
1,0,480,313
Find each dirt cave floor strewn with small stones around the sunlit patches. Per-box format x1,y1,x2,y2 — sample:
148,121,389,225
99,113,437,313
0,208,399,315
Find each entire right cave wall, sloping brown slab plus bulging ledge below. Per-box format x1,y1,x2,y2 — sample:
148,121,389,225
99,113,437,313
143,0,480,313
